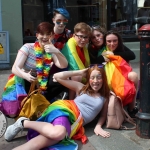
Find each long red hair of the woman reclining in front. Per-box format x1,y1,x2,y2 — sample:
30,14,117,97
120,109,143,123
79,65,110,98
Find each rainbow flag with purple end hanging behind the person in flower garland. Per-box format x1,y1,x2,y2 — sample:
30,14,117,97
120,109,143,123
0,74,27,115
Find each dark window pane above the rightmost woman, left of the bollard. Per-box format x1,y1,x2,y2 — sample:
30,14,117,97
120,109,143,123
110,0,137,35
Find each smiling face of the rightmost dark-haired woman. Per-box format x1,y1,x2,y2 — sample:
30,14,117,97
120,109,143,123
106,34,118,52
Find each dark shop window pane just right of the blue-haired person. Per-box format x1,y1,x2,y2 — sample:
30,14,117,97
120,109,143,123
66,0,107,31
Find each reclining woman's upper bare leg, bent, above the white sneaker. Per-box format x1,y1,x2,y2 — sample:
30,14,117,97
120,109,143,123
24,120,66,141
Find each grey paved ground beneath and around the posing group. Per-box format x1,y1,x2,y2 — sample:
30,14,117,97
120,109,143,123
0,62,150,150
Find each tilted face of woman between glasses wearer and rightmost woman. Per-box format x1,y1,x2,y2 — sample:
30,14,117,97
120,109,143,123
90,30,104,48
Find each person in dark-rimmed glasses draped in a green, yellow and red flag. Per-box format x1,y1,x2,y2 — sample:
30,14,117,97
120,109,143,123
61,22,91,99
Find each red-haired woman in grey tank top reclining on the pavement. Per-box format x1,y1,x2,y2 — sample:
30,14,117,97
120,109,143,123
4,65,110,150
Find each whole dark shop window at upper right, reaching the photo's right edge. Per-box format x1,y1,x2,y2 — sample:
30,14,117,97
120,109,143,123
108,0,150,40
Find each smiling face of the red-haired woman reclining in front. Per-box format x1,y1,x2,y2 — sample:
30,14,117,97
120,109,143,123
89,70,103,92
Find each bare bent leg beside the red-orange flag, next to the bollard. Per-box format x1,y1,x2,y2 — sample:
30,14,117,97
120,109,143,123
128,72,138,111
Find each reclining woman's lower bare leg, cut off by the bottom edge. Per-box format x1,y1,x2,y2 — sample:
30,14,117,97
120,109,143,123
13,135,59,150
